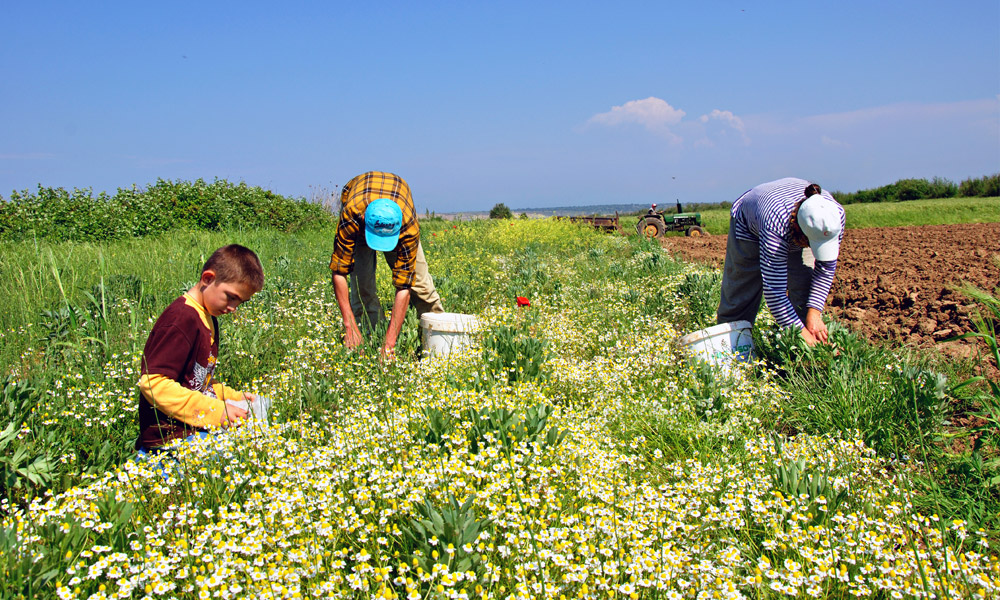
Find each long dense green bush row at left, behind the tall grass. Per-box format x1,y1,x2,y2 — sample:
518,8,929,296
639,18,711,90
0,179,333,242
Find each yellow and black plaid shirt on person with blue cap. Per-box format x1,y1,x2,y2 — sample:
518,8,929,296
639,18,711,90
330,171,420,289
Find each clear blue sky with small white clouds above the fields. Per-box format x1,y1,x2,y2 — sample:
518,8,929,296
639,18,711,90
0,0,1000,212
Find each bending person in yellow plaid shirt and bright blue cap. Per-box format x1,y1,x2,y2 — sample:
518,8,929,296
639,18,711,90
330,171,444,357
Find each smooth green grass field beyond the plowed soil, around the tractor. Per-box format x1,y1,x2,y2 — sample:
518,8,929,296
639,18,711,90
648,198,1000,235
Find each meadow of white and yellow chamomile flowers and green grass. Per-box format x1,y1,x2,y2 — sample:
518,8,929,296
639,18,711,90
0,219,1000,600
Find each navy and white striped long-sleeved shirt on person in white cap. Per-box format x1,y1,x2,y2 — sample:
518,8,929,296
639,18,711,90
730,177,845,328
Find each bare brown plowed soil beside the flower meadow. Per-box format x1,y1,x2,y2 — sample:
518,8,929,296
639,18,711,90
663,223,1000,354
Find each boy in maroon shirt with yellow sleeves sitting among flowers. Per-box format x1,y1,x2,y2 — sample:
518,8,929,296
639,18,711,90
135,244,264,455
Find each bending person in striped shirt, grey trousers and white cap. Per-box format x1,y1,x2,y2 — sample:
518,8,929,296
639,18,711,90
718,177,845,346
